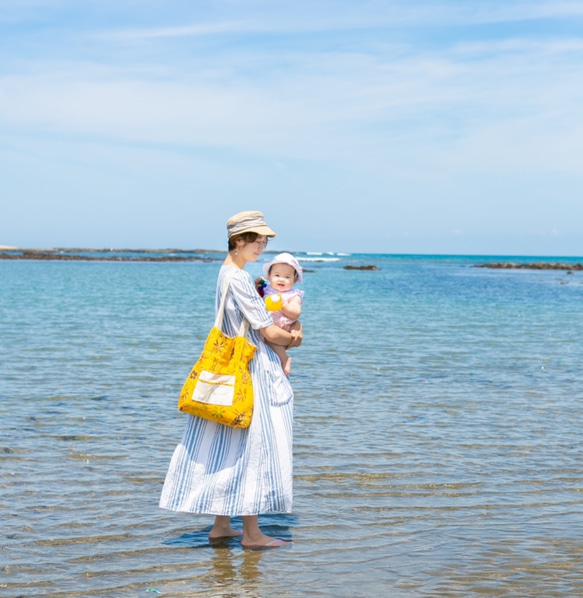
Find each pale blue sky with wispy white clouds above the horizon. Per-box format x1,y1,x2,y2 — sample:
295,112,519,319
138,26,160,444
0,0,583,256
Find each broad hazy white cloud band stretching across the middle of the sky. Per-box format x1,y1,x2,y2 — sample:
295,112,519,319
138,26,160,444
0,24,583,178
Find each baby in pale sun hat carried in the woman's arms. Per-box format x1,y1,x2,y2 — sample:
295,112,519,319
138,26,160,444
256,253,304,376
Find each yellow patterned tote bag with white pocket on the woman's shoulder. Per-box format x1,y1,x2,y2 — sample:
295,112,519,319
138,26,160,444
178,278,257,428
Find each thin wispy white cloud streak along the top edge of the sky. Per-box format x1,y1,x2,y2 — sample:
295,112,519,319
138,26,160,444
86,0,583,40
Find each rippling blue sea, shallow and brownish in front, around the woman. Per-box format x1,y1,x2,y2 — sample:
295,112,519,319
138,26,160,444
0,254,583,598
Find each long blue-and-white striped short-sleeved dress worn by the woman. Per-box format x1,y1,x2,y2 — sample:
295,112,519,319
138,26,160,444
160,266,293,516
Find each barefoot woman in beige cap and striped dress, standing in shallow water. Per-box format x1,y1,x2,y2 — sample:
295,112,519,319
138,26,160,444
160,212,302,548
